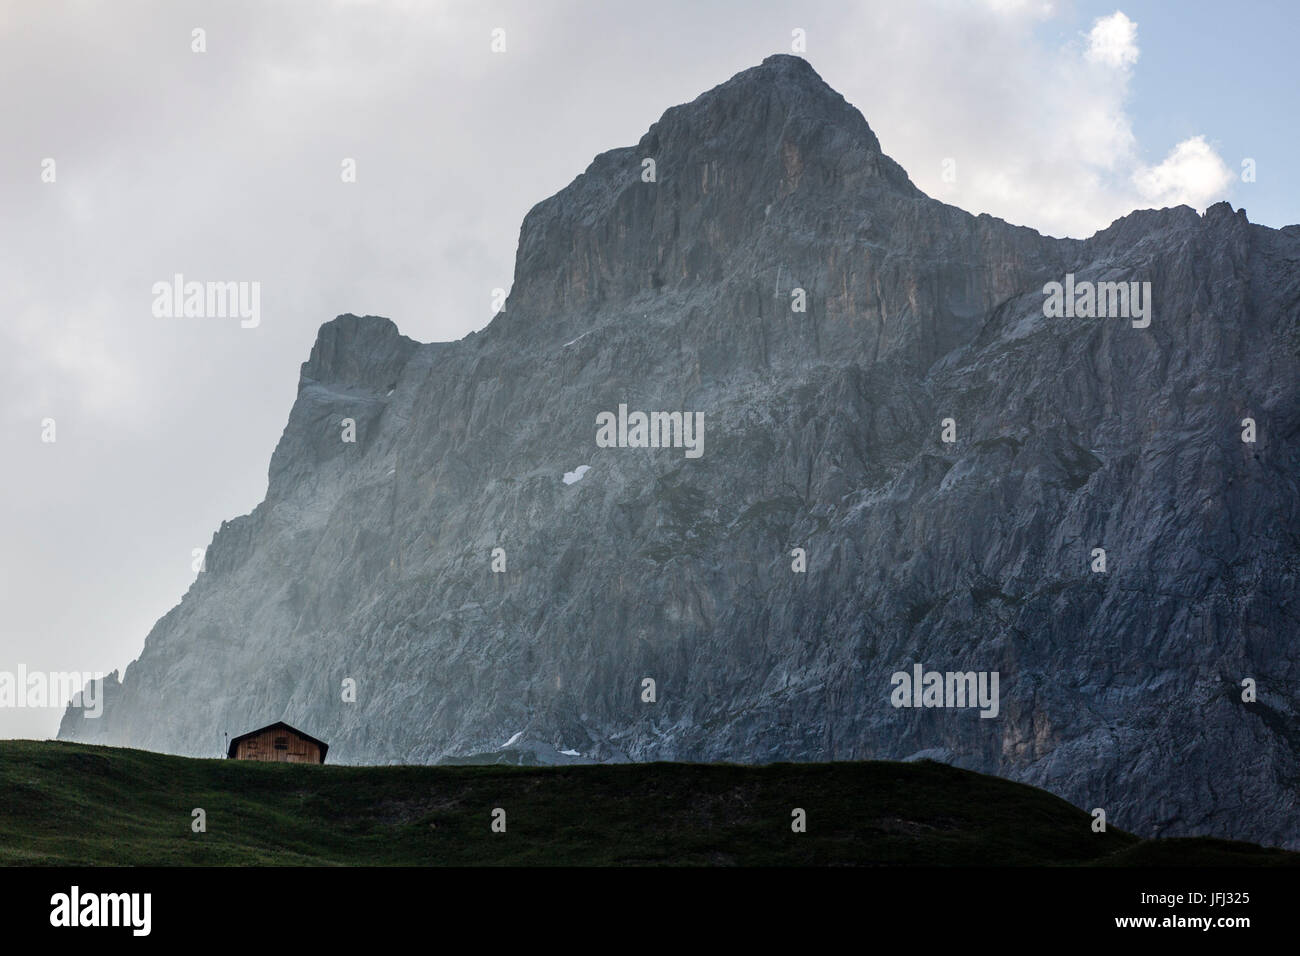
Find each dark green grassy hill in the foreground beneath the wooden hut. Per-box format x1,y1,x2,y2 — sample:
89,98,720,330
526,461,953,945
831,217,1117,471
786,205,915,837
0,740,1300,866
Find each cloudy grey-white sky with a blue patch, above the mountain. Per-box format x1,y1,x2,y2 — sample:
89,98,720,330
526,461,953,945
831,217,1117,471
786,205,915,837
0,0,1300,737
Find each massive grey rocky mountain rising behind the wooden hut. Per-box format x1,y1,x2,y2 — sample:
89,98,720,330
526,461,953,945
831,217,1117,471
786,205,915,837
60,56,1300,848
